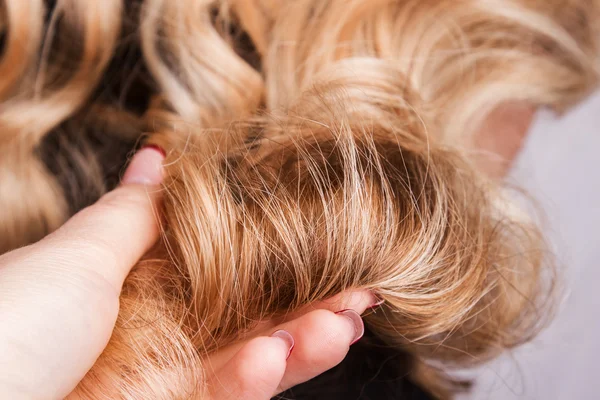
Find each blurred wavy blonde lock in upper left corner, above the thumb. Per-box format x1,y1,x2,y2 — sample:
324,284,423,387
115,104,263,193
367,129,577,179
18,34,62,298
0,0,122,252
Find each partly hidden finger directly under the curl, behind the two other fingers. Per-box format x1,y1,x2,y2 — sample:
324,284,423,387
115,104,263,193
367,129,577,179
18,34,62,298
207,290,380,371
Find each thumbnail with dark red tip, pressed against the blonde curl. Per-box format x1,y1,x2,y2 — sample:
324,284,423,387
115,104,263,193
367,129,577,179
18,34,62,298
121,145,165,185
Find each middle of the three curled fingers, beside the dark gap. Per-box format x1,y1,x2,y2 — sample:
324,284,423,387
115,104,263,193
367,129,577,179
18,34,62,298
279,310,364,391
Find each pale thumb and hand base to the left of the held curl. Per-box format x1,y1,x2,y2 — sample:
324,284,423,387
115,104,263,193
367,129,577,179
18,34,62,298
0,145,162,398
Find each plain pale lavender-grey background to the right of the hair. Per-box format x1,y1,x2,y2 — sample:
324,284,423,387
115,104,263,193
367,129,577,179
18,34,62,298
465,94,600,400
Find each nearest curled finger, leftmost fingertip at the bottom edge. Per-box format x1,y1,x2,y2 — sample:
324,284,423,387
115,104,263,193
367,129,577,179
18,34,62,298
208,331,294,400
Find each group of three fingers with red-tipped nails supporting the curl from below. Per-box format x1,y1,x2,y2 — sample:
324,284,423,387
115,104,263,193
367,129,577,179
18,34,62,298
205,291,380,400
